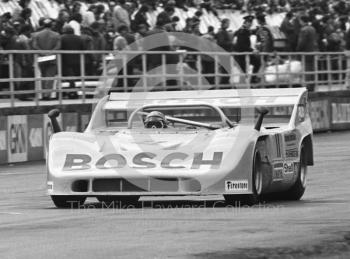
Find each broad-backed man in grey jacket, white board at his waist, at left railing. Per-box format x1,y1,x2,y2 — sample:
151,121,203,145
32,18,61,100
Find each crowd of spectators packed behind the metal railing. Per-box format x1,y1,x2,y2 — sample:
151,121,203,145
0,0,350,98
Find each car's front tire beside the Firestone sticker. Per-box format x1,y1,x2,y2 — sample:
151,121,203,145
224,150,263,207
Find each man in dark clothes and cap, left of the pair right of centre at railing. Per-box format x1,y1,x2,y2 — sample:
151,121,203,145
234,15,261,83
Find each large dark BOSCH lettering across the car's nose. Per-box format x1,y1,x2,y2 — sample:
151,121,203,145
62,152,223,171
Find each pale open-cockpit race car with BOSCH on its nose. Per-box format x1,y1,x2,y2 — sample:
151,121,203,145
47,88,313,208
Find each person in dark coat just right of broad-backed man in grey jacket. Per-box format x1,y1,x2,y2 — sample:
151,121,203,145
61,25,85,99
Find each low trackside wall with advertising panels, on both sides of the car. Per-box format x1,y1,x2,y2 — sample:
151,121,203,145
0,91,350,164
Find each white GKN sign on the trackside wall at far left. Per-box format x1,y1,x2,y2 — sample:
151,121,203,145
7,115,27,163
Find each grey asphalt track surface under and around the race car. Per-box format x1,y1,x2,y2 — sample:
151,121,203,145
0,132,350,258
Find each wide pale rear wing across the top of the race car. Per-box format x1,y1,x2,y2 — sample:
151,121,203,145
104,88,307,109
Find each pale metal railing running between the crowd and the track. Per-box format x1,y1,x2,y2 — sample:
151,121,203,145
0,50,350,107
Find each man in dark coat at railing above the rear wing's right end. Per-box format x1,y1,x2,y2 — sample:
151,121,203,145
297,15,318,91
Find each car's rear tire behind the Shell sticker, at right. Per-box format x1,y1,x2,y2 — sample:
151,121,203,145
282,144,307,201
